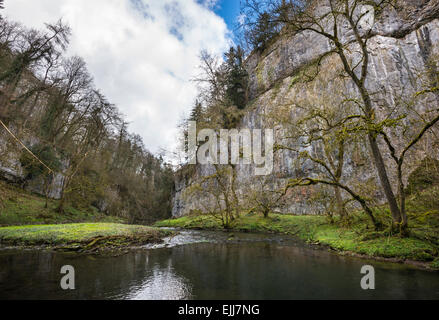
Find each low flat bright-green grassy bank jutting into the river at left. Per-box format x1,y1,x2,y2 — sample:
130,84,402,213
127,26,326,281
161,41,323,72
0,223,171,253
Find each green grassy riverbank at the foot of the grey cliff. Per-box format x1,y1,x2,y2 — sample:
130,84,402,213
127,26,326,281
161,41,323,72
154,214,439,269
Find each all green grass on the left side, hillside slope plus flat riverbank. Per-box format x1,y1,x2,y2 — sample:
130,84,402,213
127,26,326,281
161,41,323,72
0,182,172,253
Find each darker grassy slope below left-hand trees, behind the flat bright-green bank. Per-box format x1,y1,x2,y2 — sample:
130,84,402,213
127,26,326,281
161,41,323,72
0,181,125,227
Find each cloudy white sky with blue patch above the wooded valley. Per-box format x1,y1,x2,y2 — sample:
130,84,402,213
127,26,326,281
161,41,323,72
4,0,239,160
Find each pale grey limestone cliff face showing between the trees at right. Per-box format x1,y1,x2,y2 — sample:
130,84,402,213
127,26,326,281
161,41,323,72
172,0,439,216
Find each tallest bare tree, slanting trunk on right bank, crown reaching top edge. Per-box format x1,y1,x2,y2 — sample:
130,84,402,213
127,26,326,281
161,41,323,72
241,0,439,233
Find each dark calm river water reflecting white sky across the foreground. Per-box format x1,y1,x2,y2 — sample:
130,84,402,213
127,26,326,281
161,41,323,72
0,231,439,300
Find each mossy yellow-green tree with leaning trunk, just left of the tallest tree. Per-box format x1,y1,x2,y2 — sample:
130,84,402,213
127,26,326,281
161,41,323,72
271,89,381,229
